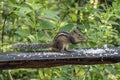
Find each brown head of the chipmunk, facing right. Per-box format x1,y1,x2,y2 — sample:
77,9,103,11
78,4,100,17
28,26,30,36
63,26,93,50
70,29,84,44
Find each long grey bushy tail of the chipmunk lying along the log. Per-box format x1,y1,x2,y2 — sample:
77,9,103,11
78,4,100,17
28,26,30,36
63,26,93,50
12,43,51,49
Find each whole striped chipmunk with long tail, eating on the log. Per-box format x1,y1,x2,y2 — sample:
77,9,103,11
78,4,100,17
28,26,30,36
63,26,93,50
12,29,84,52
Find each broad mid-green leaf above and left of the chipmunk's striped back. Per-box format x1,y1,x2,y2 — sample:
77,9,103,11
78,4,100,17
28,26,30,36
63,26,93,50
37,21,56,30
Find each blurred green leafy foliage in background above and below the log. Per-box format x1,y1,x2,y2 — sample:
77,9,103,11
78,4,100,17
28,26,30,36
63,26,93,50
0,0,120,80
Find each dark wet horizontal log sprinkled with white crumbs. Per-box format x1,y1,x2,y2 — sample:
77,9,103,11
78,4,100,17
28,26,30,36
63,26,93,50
0,47,120,69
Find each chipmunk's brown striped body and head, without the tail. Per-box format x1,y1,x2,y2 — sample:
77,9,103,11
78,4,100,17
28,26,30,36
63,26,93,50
51,30,83,51
